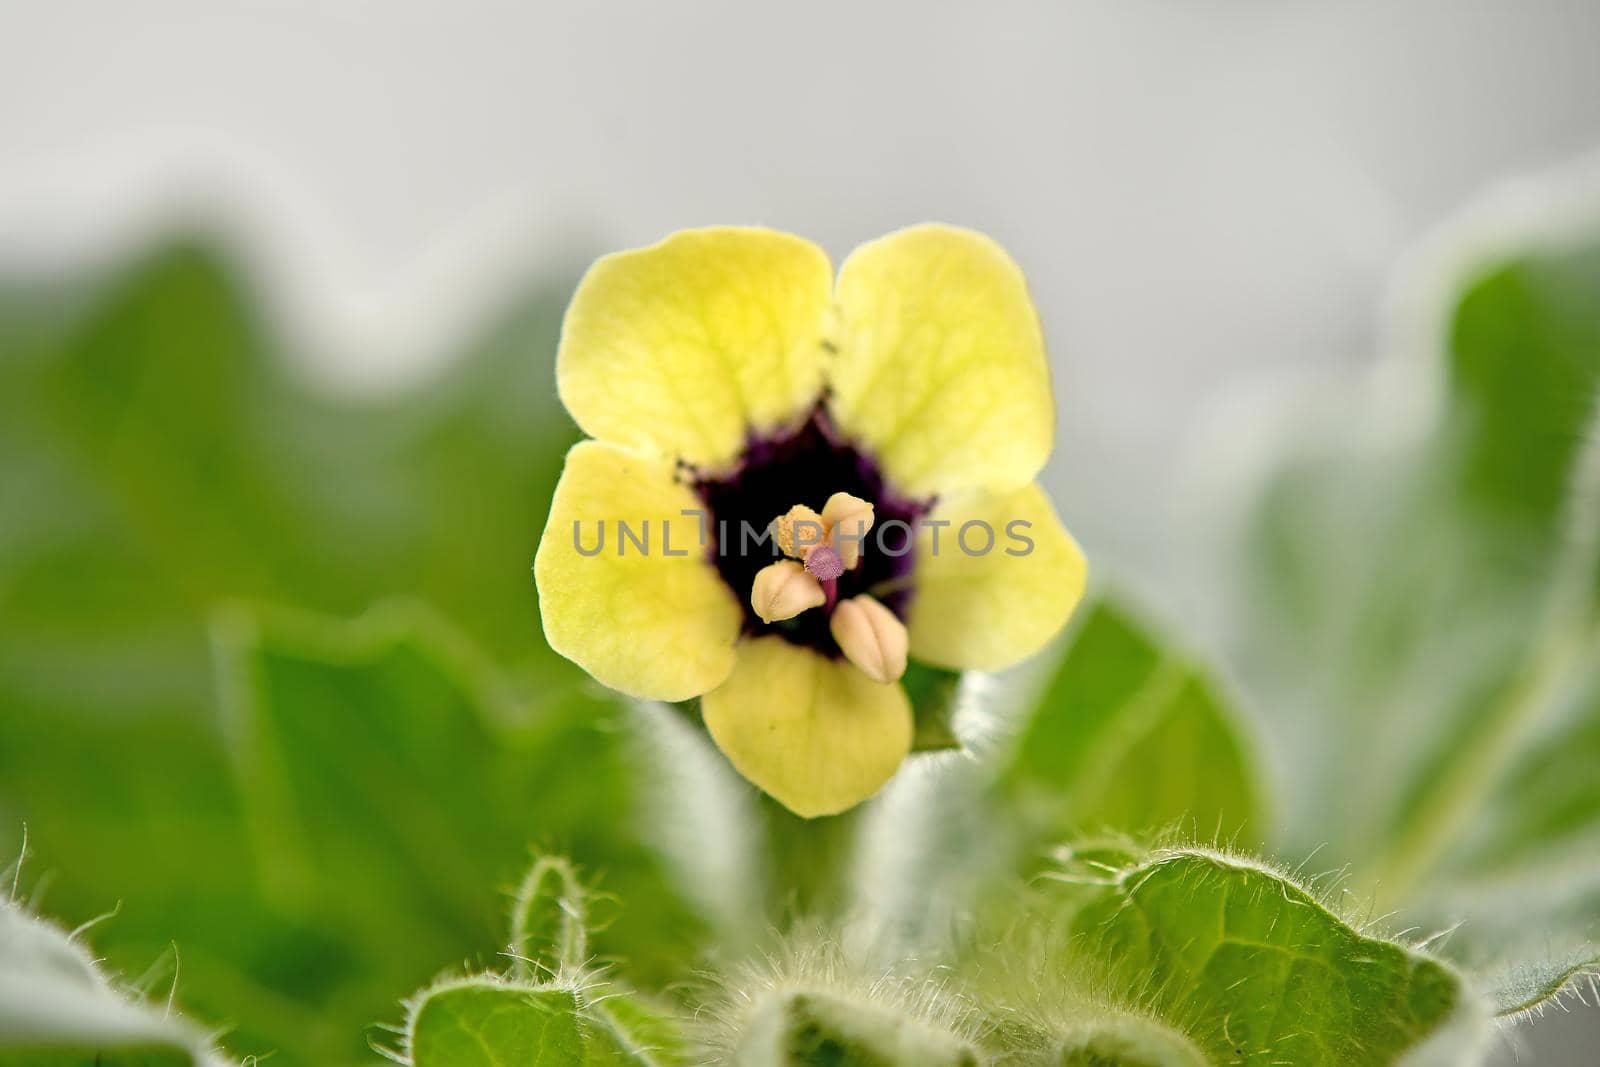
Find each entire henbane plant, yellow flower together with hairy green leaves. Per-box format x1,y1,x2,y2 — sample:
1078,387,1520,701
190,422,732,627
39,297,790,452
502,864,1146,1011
0,163,1600,1067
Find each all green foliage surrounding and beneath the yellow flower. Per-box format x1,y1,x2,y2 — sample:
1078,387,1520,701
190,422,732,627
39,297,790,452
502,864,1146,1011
0,194,1600,1067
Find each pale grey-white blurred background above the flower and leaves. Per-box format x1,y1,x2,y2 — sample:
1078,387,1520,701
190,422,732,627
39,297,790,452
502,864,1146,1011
0,0,1600,1064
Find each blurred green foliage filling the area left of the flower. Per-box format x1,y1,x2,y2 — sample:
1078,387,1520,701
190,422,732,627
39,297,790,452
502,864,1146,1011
0,242,707,1064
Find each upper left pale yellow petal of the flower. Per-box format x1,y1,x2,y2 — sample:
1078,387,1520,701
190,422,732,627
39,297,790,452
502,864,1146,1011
555,227,832,469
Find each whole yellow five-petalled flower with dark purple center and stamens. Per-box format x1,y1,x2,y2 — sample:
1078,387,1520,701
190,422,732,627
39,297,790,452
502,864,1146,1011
534,226,1085,816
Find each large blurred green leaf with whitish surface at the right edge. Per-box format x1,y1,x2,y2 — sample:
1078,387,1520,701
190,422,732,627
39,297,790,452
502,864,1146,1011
1216,189,1600,1011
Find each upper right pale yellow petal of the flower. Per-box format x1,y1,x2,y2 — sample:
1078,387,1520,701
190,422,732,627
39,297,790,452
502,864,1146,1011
829,224,1054,496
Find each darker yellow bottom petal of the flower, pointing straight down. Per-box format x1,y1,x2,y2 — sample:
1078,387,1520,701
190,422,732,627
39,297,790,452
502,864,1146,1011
701,637,910,819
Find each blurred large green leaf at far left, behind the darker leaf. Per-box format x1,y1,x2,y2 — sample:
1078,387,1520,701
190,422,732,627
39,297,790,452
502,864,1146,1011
0,240,579,1067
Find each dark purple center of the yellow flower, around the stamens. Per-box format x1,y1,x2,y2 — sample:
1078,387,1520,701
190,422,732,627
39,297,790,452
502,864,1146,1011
691,408,933,656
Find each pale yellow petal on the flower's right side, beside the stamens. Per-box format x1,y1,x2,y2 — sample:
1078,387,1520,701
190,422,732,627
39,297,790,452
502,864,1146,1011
907,485,1088,670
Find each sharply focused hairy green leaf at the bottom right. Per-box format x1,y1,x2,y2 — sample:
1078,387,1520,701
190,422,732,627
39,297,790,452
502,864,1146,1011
1045,849,1485,1067
